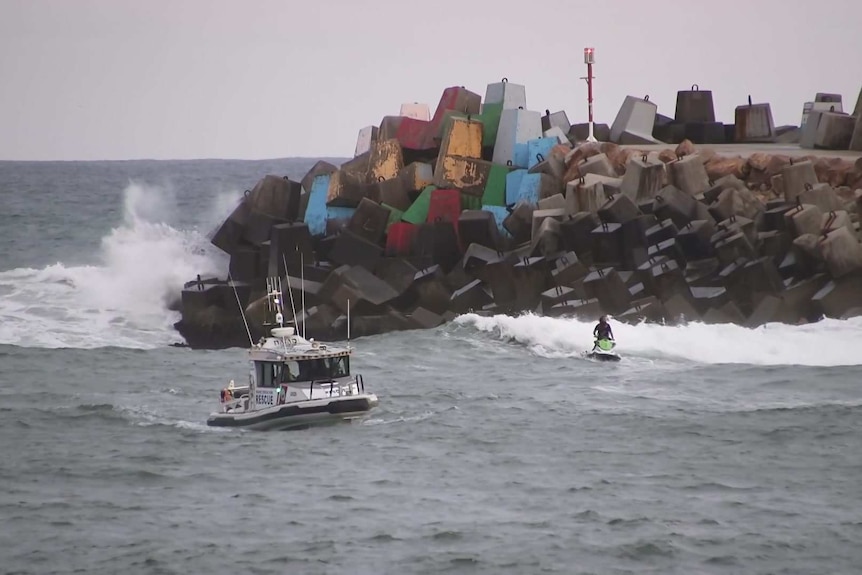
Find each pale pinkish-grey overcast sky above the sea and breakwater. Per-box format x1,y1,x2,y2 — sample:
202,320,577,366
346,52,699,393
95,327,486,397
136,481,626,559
0,0,862,160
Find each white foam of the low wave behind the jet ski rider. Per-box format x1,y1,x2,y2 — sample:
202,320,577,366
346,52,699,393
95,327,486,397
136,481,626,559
455,314,862,366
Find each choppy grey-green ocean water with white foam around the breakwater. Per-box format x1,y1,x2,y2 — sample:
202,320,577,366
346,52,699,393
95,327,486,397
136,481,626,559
0,159,862,574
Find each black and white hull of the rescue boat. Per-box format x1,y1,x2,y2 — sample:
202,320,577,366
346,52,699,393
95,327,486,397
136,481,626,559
207,393,377,431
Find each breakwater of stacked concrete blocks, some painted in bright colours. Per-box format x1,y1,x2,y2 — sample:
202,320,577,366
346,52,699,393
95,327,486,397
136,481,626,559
176,81,862,347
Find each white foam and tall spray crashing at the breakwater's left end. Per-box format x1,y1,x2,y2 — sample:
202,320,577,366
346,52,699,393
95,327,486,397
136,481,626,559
0,182,233,348
